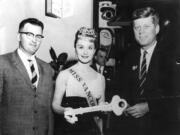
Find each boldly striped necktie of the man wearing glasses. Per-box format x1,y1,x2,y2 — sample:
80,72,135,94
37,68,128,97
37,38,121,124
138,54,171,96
28,60,37,87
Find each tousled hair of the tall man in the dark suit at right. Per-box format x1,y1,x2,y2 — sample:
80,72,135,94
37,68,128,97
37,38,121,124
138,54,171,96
132,7,159,25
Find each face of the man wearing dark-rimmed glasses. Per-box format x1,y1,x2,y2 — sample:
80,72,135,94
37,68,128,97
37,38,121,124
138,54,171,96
18,23,43,55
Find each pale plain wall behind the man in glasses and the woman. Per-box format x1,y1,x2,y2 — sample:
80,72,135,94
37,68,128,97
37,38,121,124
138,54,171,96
0,0,93,62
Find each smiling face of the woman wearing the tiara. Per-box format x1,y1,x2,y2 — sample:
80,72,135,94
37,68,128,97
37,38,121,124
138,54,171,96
75,38,96,64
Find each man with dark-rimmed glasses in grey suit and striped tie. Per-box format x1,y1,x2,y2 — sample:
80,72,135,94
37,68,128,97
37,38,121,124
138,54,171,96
0,18,53,135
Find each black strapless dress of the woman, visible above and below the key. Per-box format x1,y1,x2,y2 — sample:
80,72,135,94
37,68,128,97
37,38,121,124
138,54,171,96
62,97,97,135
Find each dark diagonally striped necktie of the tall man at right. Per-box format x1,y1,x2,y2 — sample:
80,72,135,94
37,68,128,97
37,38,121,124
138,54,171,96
139,51,147,95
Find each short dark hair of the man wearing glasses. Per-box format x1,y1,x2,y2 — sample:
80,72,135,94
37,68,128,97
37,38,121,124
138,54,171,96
19,18,44,31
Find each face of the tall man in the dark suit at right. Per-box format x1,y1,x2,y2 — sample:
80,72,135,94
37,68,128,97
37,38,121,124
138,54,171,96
133,16,159,49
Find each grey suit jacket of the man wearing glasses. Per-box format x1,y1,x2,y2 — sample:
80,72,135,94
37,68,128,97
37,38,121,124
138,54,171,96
0,51,53,135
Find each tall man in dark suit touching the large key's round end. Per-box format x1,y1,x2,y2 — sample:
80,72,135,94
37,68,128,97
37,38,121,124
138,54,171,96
112,7,178,135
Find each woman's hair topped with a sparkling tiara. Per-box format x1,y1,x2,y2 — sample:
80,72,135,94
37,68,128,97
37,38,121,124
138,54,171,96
74,27,98,49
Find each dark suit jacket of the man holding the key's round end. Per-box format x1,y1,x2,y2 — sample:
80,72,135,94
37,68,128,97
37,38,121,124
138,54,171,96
116,41,179,135
